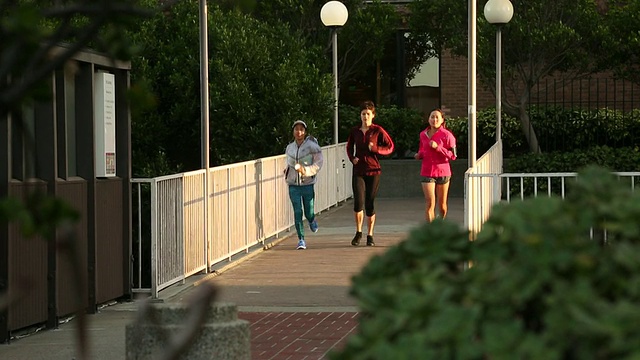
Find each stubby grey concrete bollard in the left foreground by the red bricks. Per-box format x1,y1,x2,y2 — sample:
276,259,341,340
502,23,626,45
125,303,251,360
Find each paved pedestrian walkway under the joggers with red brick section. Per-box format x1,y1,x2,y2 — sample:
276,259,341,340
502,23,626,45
0,198,464,360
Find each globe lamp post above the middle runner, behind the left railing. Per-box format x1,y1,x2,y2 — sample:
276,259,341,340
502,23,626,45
320,1,349,144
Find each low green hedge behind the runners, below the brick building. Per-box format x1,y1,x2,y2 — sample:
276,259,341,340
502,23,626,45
339,105,640,172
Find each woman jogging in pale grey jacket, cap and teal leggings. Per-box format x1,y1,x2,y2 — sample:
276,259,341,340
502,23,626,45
284,120,323,250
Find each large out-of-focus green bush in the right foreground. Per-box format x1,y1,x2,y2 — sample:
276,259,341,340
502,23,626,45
331,168,640,360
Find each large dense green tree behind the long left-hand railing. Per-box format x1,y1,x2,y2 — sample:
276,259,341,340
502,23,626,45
132,0,333,175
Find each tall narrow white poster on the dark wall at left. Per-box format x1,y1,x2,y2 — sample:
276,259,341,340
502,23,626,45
93,71,116,177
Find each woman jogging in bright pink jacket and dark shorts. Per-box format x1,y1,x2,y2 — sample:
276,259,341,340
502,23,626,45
414,109,457,222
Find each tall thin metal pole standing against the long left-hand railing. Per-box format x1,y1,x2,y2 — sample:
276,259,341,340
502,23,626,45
200,0,209,273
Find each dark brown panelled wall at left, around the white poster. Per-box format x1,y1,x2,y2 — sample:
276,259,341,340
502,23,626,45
0,51,131,343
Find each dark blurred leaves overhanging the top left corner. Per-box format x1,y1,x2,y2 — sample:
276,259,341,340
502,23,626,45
0,0,171,118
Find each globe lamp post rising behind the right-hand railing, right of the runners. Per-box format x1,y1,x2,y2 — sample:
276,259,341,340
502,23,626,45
484,0,513,141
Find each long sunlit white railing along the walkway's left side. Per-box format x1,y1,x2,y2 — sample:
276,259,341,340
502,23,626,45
131,143,353,298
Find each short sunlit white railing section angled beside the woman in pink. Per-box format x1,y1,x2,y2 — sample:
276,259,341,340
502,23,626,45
464,140,502,238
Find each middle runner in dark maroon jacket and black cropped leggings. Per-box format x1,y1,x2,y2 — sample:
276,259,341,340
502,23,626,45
347,101,394,246
